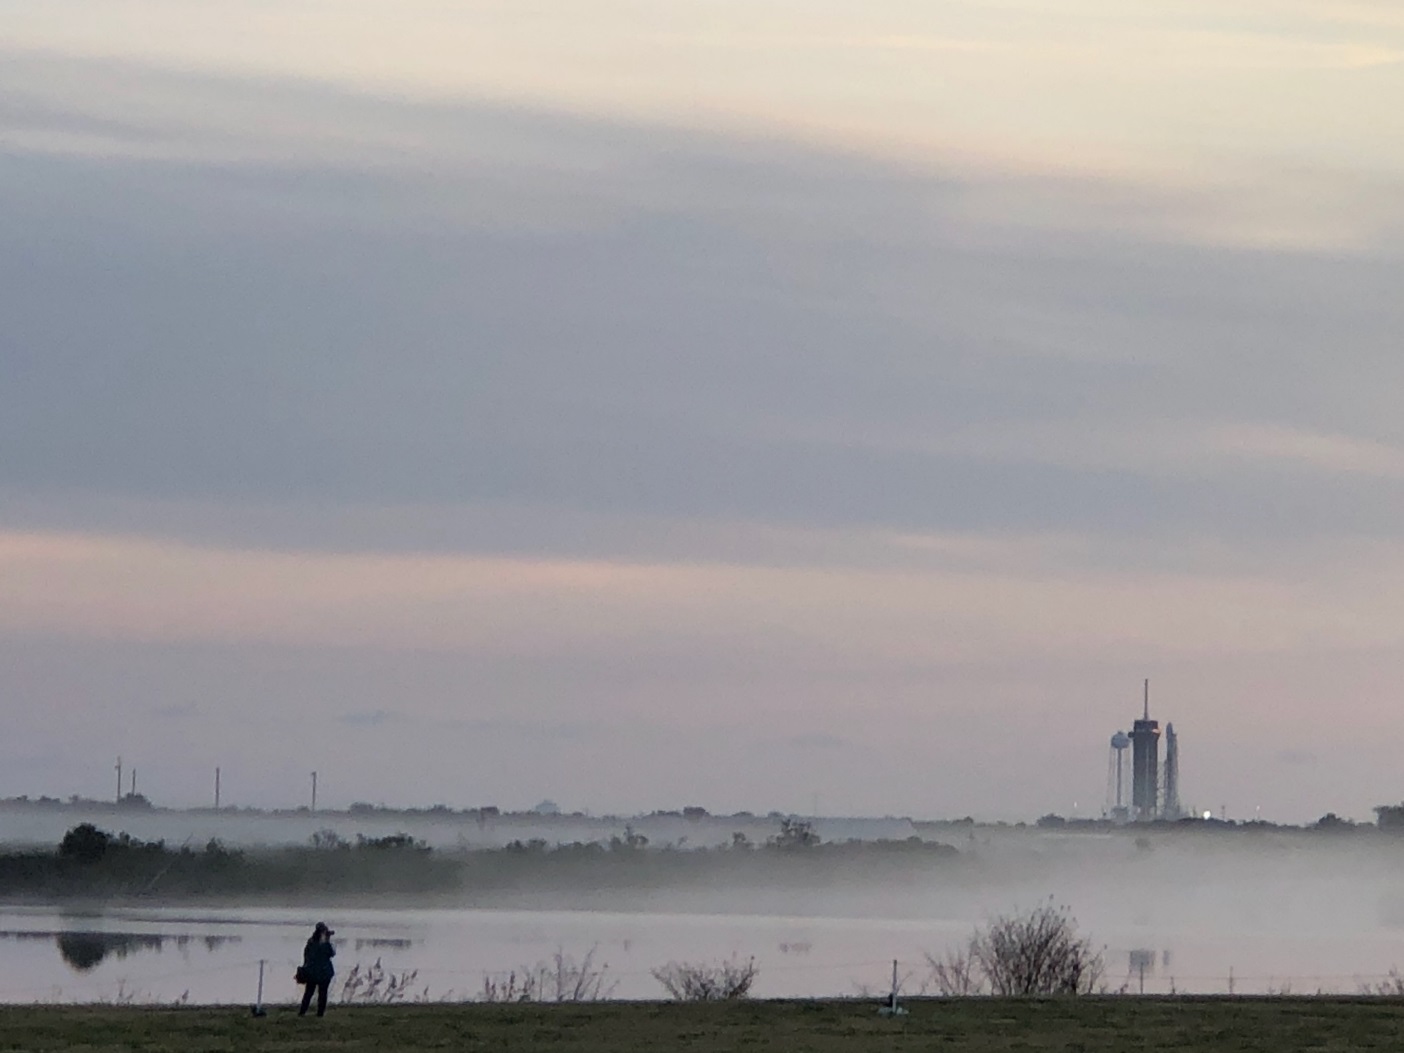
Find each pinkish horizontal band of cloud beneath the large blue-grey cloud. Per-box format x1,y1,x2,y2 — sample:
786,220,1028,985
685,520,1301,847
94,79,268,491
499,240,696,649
10,534,1404,676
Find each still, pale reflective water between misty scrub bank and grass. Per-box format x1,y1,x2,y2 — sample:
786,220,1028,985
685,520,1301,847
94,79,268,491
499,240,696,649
0,908,1404,1002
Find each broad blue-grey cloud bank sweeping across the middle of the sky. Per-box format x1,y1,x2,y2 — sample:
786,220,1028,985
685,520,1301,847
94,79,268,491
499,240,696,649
0,56,1404,564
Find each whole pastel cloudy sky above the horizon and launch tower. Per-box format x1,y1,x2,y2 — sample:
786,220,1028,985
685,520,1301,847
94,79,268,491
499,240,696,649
0,0,1404,821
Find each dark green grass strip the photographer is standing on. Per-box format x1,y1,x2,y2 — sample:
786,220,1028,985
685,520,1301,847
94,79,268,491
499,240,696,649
0,998,1404,1053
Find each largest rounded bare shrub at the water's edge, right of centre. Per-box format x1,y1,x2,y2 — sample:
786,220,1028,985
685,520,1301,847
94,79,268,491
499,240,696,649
927,903,1105,997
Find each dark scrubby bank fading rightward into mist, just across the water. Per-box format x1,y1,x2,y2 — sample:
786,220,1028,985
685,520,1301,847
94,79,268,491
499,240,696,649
0,820,958,906
